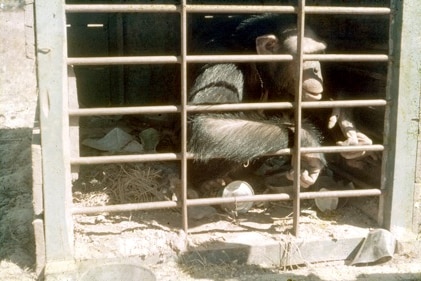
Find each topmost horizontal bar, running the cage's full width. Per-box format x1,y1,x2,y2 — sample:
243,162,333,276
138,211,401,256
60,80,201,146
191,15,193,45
65,4,391,15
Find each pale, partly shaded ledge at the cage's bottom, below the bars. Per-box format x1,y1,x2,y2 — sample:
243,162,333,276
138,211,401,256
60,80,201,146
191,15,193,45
181,233,364,267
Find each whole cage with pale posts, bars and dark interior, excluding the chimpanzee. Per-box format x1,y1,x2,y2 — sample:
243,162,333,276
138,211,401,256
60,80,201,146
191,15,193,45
34,0,420,277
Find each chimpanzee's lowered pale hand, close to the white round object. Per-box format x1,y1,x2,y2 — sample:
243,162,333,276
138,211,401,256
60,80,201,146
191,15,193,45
287,155,325,188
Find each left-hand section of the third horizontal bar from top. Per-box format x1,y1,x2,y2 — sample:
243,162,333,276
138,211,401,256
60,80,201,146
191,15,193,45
69,105,181,116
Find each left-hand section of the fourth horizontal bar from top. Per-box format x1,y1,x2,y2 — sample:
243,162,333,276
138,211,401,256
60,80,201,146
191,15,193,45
70,153,181,165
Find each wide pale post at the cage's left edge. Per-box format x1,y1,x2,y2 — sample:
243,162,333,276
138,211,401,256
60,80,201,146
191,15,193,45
35,1,73,262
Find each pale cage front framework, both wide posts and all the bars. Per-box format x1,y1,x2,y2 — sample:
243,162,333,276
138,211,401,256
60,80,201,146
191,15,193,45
35,0,421,274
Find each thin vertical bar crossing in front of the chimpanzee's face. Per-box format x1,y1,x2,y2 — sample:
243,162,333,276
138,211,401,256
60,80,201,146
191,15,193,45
293,0,306,236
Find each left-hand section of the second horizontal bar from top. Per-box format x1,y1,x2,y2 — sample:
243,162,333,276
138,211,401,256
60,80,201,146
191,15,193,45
67,56,181,65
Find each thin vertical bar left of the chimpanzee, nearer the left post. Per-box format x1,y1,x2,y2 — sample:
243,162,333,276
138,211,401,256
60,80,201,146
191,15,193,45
180,0,189,233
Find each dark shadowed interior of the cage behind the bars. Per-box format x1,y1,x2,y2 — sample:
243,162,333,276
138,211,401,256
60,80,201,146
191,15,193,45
67,0,390,212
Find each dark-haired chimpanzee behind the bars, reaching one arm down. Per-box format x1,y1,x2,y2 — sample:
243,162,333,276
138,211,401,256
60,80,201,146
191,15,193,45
188,14,326,192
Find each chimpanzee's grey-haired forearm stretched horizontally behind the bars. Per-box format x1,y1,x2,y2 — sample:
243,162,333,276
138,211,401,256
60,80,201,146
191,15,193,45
189,113,289,162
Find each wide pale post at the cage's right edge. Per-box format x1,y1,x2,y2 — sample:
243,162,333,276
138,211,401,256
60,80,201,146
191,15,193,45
379,0,421,239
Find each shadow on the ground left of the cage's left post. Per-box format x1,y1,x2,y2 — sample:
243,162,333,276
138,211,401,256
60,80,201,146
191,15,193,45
0,128,35,268
